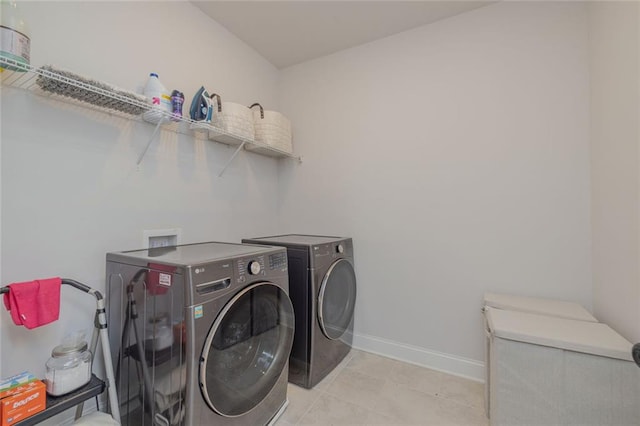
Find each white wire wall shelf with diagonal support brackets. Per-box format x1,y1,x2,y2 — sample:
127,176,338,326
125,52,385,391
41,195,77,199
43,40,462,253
0,56,302,176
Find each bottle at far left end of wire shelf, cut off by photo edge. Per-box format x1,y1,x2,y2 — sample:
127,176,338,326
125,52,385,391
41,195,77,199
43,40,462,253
0,0,31,71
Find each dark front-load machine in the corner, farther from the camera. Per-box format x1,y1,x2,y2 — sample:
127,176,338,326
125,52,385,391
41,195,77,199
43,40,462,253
242,234,357,388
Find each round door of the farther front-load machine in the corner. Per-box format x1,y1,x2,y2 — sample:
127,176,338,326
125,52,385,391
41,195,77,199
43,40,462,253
318,259,356,340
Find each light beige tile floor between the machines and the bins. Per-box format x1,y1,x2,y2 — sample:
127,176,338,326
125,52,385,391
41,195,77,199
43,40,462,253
276,349,489,426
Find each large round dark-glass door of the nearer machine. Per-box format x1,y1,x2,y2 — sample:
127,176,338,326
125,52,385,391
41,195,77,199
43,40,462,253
199,282,294,417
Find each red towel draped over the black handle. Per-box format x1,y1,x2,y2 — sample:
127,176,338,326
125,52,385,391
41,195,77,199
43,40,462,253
4,278,62,329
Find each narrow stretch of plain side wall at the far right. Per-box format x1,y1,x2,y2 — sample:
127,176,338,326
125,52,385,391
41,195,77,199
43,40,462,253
589,2,640,342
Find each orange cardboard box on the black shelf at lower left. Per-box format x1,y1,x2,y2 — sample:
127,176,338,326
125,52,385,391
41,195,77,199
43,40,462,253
0,380,47,426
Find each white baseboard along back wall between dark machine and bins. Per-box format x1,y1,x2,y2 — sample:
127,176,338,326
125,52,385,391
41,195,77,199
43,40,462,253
353,333,484,382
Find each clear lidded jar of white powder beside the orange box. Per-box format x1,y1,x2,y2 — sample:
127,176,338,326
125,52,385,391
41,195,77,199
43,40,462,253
45,341,91,396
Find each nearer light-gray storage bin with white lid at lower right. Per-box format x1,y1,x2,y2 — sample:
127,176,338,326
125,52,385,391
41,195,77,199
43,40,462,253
485,307,640,426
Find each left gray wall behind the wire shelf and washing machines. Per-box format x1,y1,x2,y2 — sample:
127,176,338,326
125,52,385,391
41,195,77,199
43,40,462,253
0,2,278,382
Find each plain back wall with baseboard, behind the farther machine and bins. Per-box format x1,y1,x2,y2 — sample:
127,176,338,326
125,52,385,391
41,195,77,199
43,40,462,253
280,2,592,378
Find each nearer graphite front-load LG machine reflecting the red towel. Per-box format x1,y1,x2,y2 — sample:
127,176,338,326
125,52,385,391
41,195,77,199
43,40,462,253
106,242,295,426
